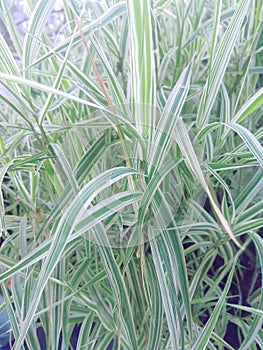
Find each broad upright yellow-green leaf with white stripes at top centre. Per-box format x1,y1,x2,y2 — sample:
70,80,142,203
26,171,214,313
127,0,156,141
